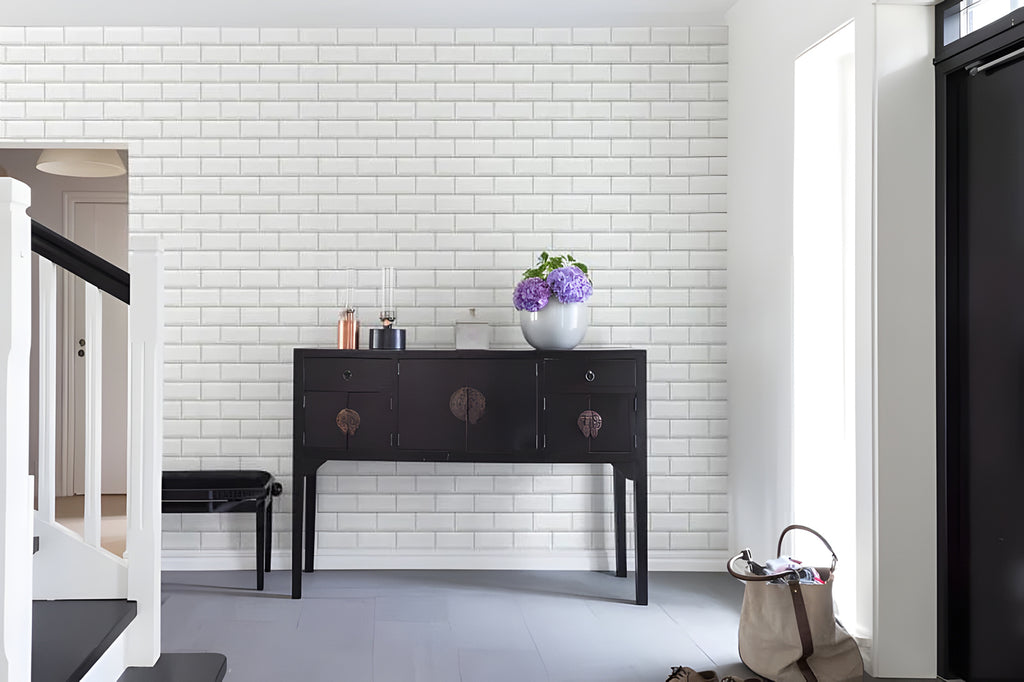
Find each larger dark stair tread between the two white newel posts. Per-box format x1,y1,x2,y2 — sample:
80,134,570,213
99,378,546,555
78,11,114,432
32,599,138,682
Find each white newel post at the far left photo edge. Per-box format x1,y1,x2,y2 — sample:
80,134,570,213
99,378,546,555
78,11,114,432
0,177,33,682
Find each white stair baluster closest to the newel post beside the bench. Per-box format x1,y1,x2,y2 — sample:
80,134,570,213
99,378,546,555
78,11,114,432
84,284,103,547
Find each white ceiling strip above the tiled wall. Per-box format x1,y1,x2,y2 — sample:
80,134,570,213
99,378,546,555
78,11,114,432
8,0,736,27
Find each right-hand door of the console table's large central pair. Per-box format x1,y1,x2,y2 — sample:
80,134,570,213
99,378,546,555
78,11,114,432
463,359,538,454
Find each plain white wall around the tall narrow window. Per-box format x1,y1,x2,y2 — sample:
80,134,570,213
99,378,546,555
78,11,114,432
727,0,936,677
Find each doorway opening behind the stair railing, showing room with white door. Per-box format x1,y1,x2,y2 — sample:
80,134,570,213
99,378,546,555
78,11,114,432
0,145,129,555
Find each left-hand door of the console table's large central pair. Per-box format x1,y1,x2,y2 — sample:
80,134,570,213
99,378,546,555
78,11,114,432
398,359,468,452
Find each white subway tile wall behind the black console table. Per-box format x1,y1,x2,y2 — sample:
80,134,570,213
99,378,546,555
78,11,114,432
0,27,728,566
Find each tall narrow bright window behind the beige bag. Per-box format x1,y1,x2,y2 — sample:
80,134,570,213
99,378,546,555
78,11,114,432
793,23,857,624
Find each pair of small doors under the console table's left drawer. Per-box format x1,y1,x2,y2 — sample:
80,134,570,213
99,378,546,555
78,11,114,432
303,391,394,450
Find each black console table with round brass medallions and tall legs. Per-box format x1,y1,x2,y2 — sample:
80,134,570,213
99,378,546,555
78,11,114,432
292,348,647,604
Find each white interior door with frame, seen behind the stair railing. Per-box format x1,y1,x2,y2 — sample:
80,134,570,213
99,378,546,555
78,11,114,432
63,195,128,495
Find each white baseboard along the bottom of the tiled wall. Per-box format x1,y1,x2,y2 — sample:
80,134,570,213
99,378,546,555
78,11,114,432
161,549,729,572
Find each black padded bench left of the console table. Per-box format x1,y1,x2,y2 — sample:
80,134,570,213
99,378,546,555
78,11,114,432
162,470,282,590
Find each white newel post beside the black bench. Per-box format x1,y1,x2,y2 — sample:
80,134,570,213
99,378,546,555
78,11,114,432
126,235,164,666
